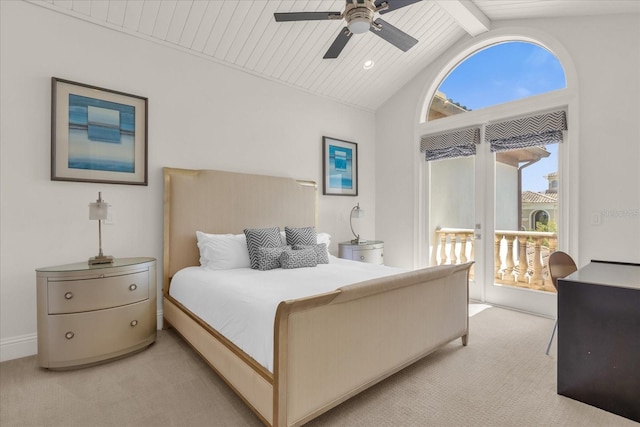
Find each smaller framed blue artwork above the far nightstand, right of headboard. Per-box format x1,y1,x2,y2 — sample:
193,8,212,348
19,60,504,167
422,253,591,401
322,136,358,196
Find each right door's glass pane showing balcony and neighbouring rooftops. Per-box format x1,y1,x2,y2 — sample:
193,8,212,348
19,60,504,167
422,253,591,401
494,144,559,292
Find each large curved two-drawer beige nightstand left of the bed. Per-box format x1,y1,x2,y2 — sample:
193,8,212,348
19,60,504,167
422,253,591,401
36,258,157,369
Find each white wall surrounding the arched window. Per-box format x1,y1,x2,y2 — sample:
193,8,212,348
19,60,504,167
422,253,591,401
376,15,640,266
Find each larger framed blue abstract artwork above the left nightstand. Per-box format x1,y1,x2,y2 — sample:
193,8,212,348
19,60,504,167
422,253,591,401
51,77,147,185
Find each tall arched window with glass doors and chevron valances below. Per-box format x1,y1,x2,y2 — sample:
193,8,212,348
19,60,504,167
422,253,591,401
416,36,577,314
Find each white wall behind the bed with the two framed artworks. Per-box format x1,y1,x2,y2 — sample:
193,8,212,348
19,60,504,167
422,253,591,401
0,1,376,360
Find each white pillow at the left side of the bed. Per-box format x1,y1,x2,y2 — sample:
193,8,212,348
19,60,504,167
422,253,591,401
196,231,251,270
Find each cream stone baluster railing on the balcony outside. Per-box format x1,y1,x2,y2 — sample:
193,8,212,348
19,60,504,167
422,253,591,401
435,228,558,292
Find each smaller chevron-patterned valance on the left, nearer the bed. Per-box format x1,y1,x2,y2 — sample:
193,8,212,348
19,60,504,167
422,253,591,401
420,128,480,161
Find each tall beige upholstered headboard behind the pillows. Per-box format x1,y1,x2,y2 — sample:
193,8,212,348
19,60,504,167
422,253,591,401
163,168,318,293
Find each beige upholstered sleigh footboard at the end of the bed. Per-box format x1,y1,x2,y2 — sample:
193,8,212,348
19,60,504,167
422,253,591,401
274,263,472,426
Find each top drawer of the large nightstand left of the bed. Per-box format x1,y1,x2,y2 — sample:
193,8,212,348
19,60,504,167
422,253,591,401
47,270,149,314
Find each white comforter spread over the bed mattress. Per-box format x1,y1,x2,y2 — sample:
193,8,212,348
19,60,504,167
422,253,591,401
169,256,405,372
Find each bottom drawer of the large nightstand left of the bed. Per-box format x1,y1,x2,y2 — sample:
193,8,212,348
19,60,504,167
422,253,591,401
43,301,156,368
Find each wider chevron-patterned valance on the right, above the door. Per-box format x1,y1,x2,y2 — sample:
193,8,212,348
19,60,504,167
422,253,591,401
485,111,567,152
